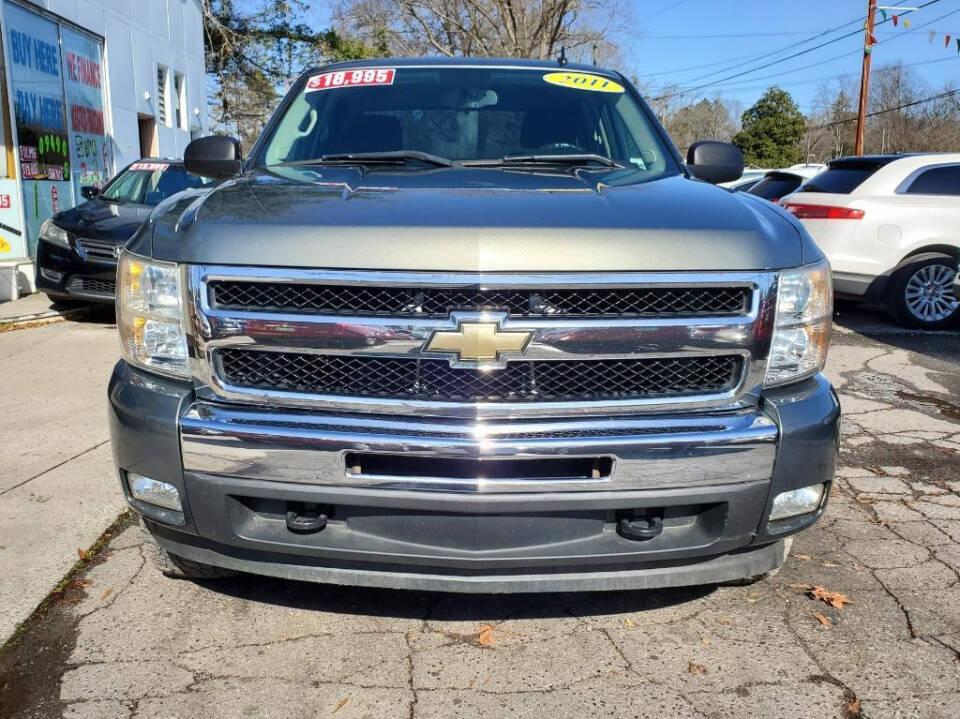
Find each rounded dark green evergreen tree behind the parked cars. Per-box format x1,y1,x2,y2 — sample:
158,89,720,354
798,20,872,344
733,87,806,167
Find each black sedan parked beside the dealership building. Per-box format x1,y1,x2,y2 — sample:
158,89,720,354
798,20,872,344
37,158,209,302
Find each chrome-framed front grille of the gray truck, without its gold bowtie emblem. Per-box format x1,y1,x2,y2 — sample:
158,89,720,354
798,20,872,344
186,265,777,419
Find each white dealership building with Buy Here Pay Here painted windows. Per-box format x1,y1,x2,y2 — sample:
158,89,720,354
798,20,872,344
0,0,207,293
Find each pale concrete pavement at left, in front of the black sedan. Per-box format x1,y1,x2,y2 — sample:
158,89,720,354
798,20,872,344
0,314,124,644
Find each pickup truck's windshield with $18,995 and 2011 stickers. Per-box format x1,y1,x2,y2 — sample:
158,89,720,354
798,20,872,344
258,67,679,179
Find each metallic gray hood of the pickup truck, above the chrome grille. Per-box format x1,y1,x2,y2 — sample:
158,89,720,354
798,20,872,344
144,166,817,272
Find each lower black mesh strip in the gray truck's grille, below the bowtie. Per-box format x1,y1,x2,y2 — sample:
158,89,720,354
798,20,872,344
219,349,742,402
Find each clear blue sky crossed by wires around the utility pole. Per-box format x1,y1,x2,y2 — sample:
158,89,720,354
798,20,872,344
621,0,960,112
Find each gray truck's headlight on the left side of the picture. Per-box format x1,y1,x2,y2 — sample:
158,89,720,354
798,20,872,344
117,252,190,378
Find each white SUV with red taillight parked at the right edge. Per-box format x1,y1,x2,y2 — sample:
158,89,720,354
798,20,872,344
781,153,960,329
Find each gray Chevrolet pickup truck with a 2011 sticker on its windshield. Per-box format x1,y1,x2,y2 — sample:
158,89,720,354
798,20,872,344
109,59,840,592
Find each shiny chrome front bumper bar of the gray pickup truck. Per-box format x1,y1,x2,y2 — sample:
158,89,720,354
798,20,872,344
180,401,778,493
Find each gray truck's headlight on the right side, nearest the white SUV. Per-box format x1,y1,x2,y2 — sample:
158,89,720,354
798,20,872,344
764,260,833,387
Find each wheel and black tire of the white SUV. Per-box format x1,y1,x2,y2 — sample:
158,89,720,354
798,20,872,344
883,255,960,330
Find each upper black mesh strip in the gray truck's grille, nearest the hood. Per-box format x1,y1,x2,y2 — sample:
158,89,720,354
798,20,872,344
210,280,750,317
